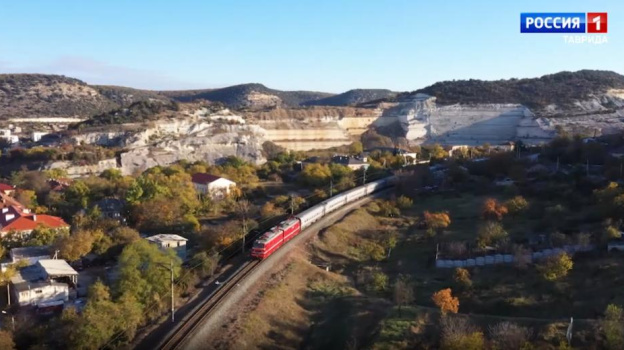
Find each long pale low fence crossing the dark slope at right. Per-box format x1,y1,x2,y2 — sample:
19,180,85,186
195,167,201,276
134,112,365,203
436,245,596,268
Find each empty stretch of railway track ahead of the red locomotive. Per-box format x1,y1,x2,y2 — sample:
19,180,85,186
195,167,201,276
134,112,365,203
160,260,261,350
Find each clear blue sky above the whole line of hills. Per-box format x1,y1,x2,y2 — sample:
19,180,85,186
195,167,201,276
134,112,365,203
0,0,624,92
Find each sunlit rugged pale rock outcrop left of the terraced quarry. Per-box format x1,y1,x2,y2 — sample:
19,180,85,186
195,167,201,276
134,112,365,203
63,111,266,176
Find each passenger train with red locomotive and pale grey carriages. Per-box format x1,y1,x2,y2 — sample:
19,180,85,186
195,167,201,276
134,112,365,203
251,176,396,259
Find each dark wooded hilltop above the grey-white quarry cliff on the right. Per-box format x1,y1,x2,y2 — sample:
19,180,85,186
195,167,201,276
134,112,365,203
412,70,624,109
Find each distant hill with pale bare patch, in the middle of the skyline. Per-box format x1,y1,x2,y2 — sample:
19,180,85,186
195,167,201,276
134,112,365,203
161,83,332,109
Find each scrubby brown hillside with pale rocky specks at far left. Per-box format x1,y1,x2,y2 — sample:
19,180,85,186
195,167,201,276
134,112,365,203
0,74,168,120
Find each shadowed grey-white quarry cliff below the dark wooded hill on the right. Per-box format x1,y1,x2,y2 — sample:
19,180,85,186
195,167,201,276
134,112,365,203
383,90,624,145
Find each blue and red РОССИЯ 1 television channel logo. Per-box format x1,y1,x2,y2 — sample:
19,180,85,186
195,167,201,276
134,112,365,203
520,12,607,34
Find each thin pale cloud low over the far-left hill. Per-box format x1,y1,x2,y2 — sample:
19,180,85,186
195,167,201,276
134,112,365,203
0,56,214,90
